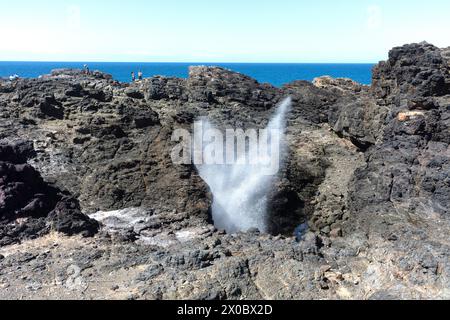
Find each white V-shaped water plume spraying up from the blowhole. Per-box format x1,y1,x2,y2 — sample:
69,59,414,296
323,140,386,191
197,98,291,233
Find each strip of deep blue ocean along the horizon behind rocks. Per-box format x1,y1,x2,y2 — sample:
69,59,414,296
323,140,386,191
0,62,374,86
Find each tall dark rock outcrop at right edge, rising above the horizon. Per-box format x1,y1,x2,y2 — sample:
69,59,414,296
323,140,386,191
350,43,450,228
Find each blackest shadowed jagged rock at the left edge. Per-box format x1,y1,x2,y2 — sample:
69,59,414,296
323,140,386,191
0,140,99,246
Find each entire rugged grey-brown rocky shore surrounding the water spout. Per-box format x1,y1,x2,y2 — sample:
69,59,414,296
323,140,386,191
0,43,450,299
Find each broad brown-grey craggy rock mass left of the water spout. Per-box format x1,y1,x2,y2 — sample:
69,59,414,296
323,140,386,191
2,70,213,232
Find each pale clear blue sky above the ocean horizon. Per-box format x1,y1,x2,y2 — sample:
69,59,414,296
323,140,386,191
0,0,450,62
